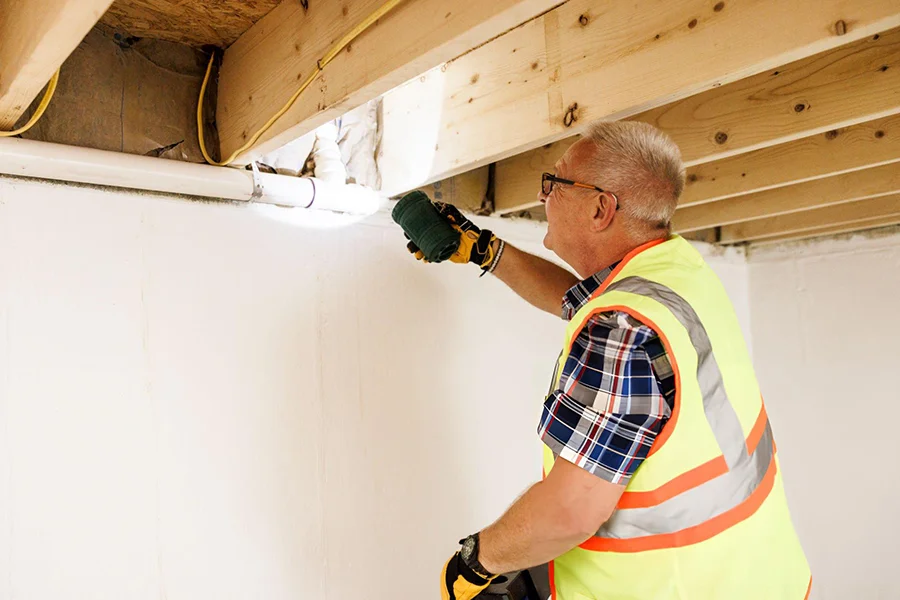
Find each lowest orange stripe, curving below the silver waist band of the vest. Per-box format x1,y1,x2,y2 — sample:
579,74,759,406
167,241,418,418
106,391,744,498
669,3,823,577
579,454,778,552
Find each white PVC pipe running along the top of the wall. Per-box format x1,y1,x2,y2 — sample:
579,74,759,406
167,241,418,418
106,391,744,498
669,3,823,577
0,138,382,215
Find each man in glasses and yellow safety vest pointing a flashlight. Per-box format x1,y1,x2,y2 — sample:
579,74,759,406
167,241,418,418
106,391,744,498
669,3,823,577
410,122,811,600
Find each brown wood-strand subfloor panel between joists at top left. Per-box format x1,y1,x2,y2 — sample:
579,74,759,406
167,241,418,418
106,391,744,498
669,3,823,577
100,0,281,48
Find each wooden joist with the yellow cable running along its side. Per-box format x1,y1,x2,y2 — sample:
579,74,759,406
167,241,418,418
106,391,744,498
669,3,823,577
216,0,560,162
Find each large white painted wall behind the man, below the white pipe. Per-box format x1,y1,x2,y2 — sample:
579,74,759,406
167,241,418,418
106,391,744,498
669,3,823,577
0,180,752,600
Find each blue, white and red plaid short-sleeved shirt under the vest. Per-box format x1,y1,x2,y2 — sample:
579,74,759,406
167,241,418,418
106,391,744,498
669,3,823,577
538,265,675,485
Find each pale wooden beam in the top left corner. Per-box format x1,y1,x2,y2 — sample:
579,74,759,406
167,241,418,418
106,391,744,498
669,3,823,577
0,0,112,130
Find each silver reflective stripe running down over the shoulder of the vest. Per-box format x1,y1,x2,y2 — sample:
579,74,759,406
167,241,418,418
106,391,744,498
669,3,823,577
606,277,747,469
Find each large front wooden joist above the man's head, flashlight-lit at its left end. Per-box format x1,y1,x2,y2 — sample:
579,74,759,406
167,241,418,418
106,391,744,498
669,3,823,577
384,0,900,201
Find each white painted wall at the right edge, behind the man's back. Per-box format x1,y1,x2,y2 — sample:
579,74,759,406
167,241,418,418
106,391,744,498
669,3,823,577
749,235,900,600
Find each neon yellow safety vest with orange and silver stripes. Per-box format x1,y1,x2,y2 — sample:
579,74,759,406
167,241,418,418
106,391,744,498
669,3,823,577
544,236,811,600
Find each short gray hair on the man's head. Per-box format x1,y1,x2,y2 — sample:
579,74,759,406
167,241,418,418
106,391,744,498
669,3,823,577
584,121,684,236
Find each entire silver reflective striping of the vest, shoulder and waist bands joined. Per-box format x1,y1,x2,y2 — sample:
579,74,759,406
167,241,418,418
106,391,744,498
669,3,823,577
597,277,774,539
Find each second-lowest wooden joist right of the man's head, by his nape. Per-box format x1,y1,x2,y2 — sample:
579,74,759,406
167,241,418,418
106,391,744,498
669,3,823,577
673,162,900,232
